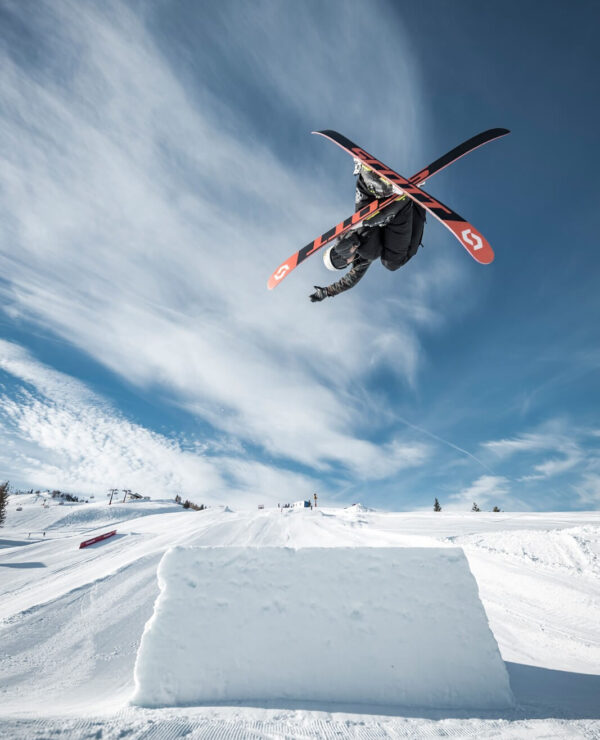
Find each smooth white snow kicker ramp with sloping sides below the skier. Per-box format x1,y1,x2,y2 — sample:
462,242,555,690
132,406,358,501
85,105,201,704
133,547,513,709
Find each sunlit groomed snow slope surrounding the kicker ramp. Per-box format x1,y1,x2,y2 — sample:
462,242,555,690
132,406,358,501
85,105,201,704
0,495,600,740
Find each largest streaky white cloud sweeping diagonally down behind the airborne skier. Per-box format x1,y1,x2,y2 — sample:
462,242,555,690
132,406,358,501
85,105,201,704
0,0,460,486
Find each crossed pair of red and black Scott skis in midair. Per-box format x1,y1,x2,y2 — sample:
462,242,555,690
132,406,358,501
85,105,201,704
267,128,510,290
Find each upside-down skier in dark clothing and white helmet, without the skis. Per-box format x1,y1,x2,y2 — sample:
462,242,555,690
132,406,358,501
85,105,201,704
310,159,425,303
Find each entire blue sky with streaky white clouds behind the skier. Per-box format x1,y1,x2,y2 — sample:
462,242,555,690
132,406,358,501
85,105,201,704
0,0,600,510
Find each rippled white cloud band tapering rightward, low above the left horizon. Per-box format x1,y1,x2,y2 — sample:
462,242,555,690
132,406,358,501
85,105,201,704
0,340,322,505
